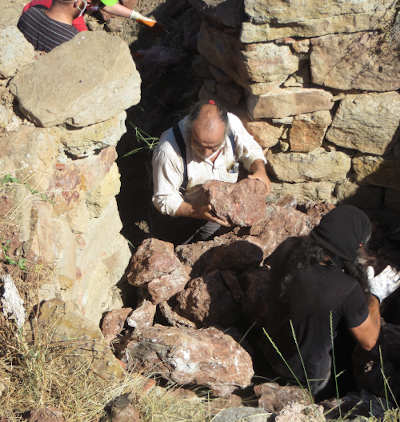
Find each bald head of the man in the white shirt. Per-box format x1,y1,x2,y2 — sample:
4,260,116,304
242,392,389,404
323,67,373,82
191,104,226,159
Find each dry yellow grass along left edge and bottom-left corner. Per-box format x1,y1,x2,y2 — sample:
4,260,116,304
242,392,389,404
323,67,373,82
0,174,214,422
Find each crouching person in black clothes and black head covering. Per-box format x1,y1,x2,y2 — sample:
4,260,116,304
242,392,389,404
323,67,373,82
262,205,380,394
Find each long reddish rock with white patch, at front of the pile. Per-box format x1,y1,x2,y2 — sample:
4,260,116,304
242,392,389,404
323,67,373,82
124,325,254,396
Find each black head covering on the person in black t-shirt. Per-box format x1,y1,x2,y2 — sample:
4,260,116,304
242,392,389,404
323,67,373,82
311,205,371,262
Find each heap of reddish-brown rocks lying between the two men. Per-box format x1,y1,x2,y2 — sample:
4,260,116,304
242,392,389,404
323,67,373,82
102,199,329,400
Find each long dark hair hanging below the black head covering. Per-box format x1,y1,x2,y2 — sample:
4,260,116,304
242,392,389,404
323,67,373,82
280,236,370,298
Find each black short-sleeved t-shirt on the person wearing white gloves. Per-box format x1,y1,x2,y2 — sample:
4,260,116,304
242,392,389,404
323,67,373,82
263,237,368,382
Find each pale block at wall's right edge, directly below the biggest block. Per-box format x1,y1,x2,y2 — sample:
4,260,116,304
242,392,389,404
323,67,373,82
326,92,400,155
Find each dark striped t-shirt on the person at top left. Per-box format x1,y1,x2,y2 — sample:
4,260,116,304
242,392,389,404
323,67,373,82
17,6,78,52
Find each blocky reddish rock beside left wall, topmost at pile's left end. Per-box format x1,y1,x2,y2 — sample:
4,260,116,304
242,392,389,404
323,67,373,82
127,239,189,305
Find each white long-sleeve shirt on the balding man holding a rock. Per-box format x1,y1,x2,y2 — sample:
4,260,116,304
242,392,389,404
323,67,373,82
153,113,266,216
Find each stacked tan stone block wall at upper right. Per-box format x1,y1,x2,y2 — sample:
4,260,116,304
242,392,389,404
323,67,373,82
190,0,400,210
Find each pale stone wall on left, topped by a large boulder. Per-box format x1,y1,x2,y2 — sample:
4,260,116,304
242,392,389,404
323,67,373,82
0,27,140,325
